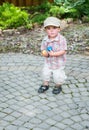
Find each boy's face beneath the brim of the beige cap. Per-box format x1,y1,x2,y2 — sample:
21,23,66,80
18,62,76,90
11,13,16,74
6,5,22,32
45,26,60,38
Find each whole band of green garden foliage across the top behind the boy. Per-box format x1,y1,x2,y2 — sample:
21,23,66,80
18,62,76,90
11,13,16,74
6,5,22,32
0,0,89,29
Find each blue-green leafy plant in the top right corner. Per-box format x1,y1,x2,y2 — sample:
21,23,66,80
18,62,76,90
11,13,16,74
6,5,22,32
54,0,89,19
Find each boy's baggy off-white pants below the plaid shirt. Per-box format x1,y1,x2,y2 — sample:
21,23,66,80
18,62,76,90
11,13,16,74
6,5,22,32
42,65,67,84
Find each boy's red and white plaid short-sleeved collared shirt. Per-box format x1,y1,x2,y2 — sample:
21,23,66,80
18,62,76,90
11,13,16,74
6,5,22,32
41,34,67,69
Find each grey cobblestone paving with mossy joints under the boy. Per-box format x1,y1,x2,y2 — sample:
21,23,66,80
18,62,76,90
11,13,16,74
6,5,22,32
0,53,89,130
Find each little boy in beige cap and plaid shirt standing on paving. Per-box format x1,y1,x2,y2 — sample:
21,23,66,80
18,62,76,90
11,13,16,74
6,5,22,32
38,17,67,94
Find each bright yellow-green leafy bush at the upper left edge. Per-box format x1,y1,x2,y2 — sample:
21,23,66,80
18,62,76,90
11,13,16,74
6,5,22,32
0,3,29,29
